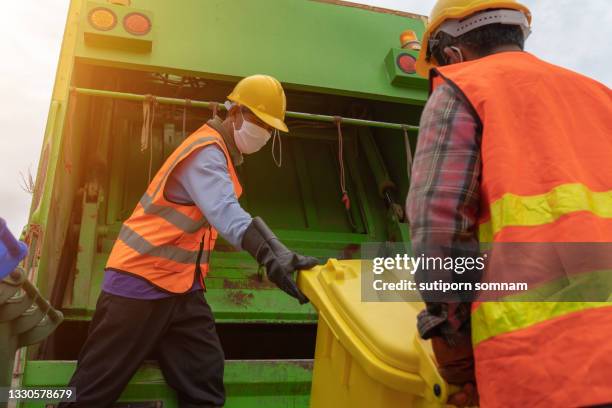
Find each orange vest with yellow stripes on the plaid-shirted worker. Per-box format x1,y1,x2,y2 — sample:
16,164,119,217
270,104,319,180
431,52,612,407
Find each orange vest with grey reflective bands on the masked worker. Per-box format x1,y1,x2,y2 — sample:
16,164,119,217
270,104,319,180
106,125,242,293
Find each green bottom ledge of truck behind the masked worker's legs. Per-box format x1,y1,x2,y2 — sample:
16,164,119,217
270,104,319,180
22,360,312,408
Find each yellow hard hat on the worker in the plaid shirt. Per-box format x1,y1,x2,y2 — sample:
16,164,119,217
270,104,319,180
416,0,531,77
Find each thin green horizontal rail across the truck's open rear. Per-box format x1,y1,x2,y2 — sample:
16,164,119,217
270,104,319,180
74,88,419,130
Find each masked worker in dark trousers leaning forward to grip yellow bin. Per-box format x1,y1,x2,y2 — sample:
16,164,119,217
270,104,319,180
61,75,317,408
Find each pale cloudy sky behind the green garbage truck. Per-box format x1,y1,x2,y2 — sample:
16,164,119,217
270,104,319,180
0,0,612,235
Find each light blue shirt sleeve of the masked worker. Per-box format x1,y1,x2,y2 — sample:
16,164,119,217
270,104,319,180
165,145,252,249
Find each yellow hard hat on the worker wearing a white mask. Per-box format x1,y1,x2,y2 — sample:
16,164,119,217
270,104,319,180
227,75,289,132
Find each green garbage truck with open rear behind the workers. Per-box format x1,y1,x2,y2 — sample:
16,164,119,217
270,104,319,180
14,0,439,408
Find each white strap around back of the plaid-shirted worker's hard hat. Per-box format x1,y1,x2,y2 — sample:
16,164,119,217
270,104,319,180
431,9,531,39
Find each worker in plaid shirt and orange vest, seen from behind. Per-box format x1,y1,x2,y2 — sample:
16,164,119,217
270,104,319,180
406,0,612,407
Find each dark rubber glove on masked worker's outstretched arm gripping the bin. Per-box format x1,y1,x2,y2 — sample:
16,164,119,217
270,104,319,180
242,217,319,304
